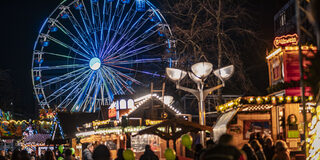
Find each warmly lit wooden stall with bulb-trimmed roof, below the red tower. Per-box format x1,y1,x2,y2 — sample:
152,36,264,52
213,96,314,151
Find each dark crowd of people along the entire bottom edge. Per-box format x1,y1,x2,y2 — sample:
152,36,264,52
0,133,290,160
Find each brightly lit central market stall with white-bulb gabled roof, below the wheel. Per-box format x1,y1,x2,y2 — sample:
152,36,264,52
73,94,180,158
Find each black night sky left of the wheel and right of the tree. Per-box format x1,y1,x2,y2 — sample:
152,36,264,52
0,0,285,113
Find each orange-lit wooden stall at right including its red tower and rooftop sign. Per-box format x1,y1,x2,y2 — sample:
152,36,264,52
214,34,317,154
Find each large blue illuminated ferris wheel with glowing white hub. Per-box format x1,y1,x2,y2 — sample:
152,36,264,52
32,0,175,112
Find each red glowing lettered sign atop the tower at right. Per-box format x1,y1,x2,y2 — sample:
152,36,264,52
273,34,299,48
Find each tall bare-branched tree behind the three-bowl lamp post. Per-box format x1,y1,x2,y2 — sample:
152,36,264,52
163,0,257,101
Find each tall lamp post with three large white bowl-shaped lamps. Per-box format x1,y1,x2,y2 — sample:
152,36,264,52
166,62,234,146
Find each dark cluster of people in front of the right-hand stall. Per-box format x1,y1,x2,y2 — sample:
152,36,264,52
194,133,290,160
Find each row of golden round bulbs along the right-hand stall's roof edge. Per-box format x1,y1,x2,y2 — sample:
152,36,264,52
216,96,313,112
